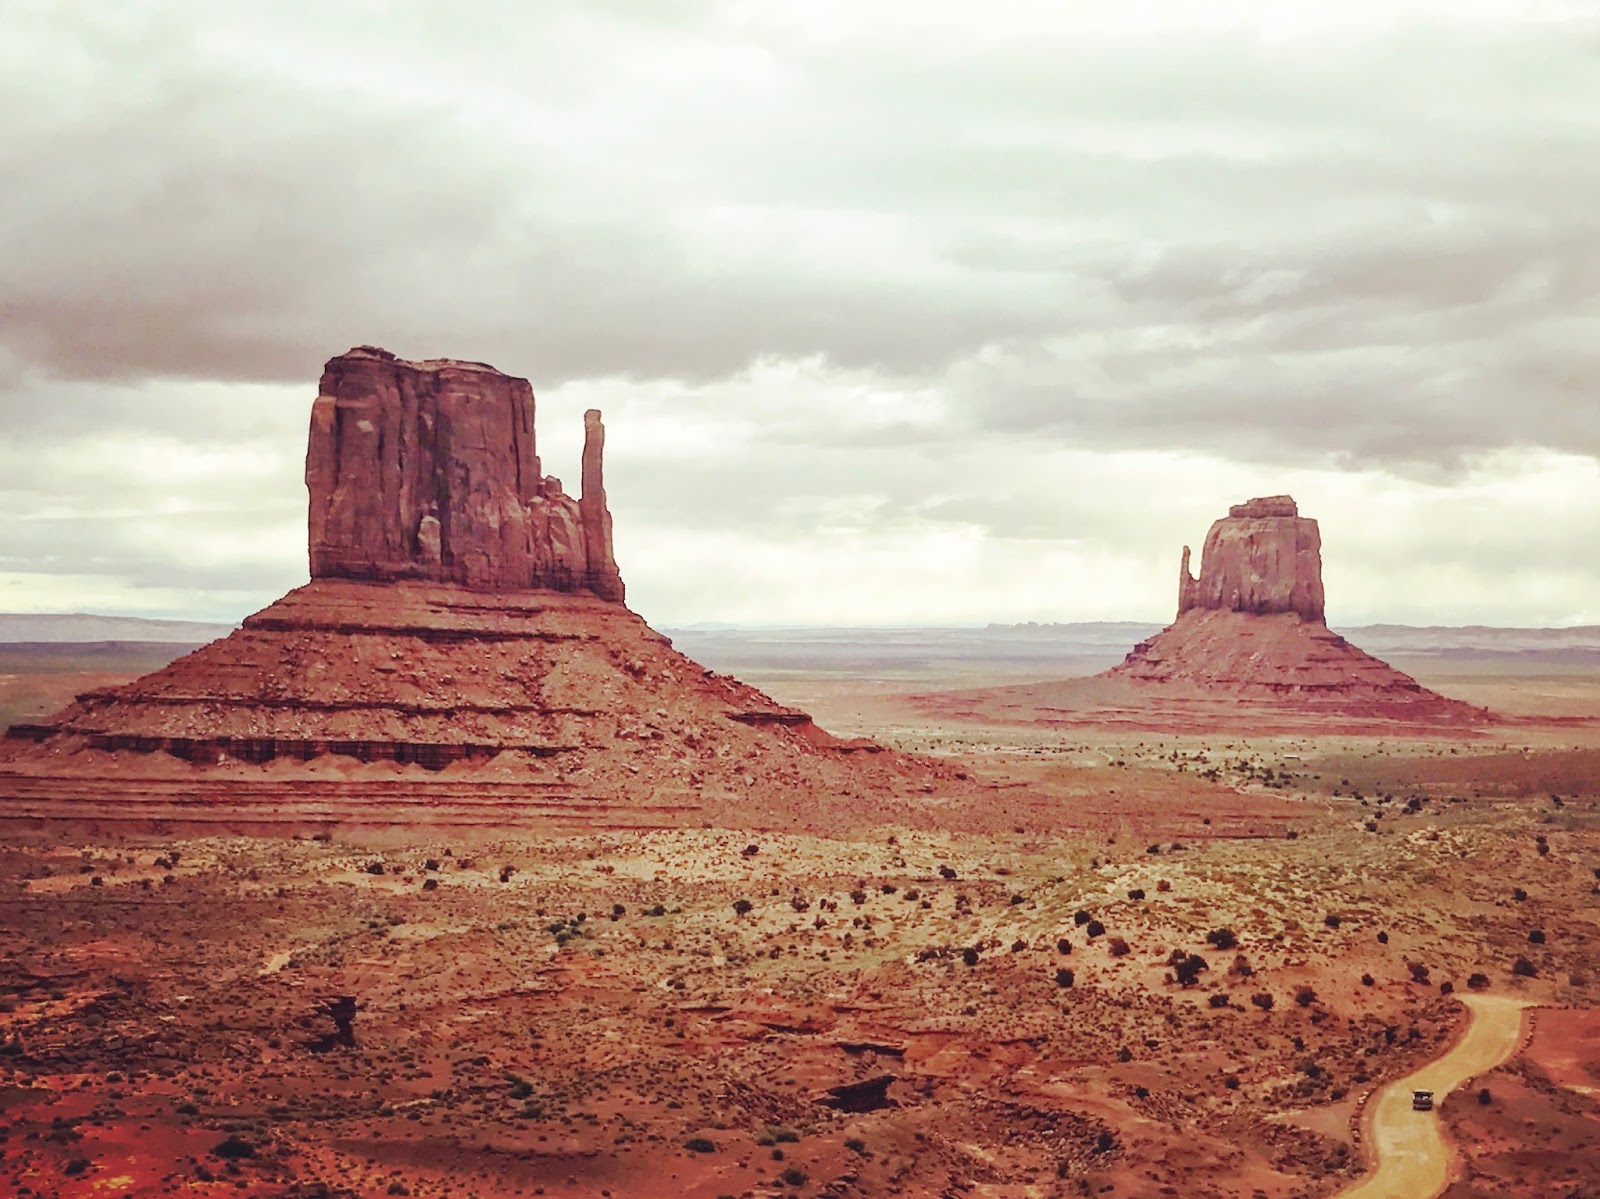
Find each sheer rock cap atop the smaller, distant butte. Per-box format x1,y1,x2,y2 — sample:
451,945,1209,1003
1178,495,1323,624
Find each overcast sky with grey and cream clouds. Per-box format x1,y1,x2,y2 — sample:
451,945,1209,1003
0,0,1600,626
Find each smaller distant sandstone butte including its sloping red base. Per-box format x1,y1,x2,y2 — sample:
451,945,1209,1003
1101,496,1488,724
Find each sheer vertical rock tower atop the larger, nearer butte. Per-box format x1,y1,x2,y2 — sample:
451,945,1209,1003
306,346,624,602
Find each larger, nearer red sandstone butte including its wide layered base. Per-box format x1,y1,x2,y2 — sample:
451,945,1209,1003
0,347,955,832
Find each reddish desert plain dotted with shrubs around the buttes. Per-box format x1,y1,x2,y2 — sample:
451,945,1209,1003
0,632,1600,1199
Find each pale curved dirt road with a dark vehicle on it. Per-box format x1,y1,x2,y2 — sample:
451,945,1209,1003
1338,996,1530,1199
